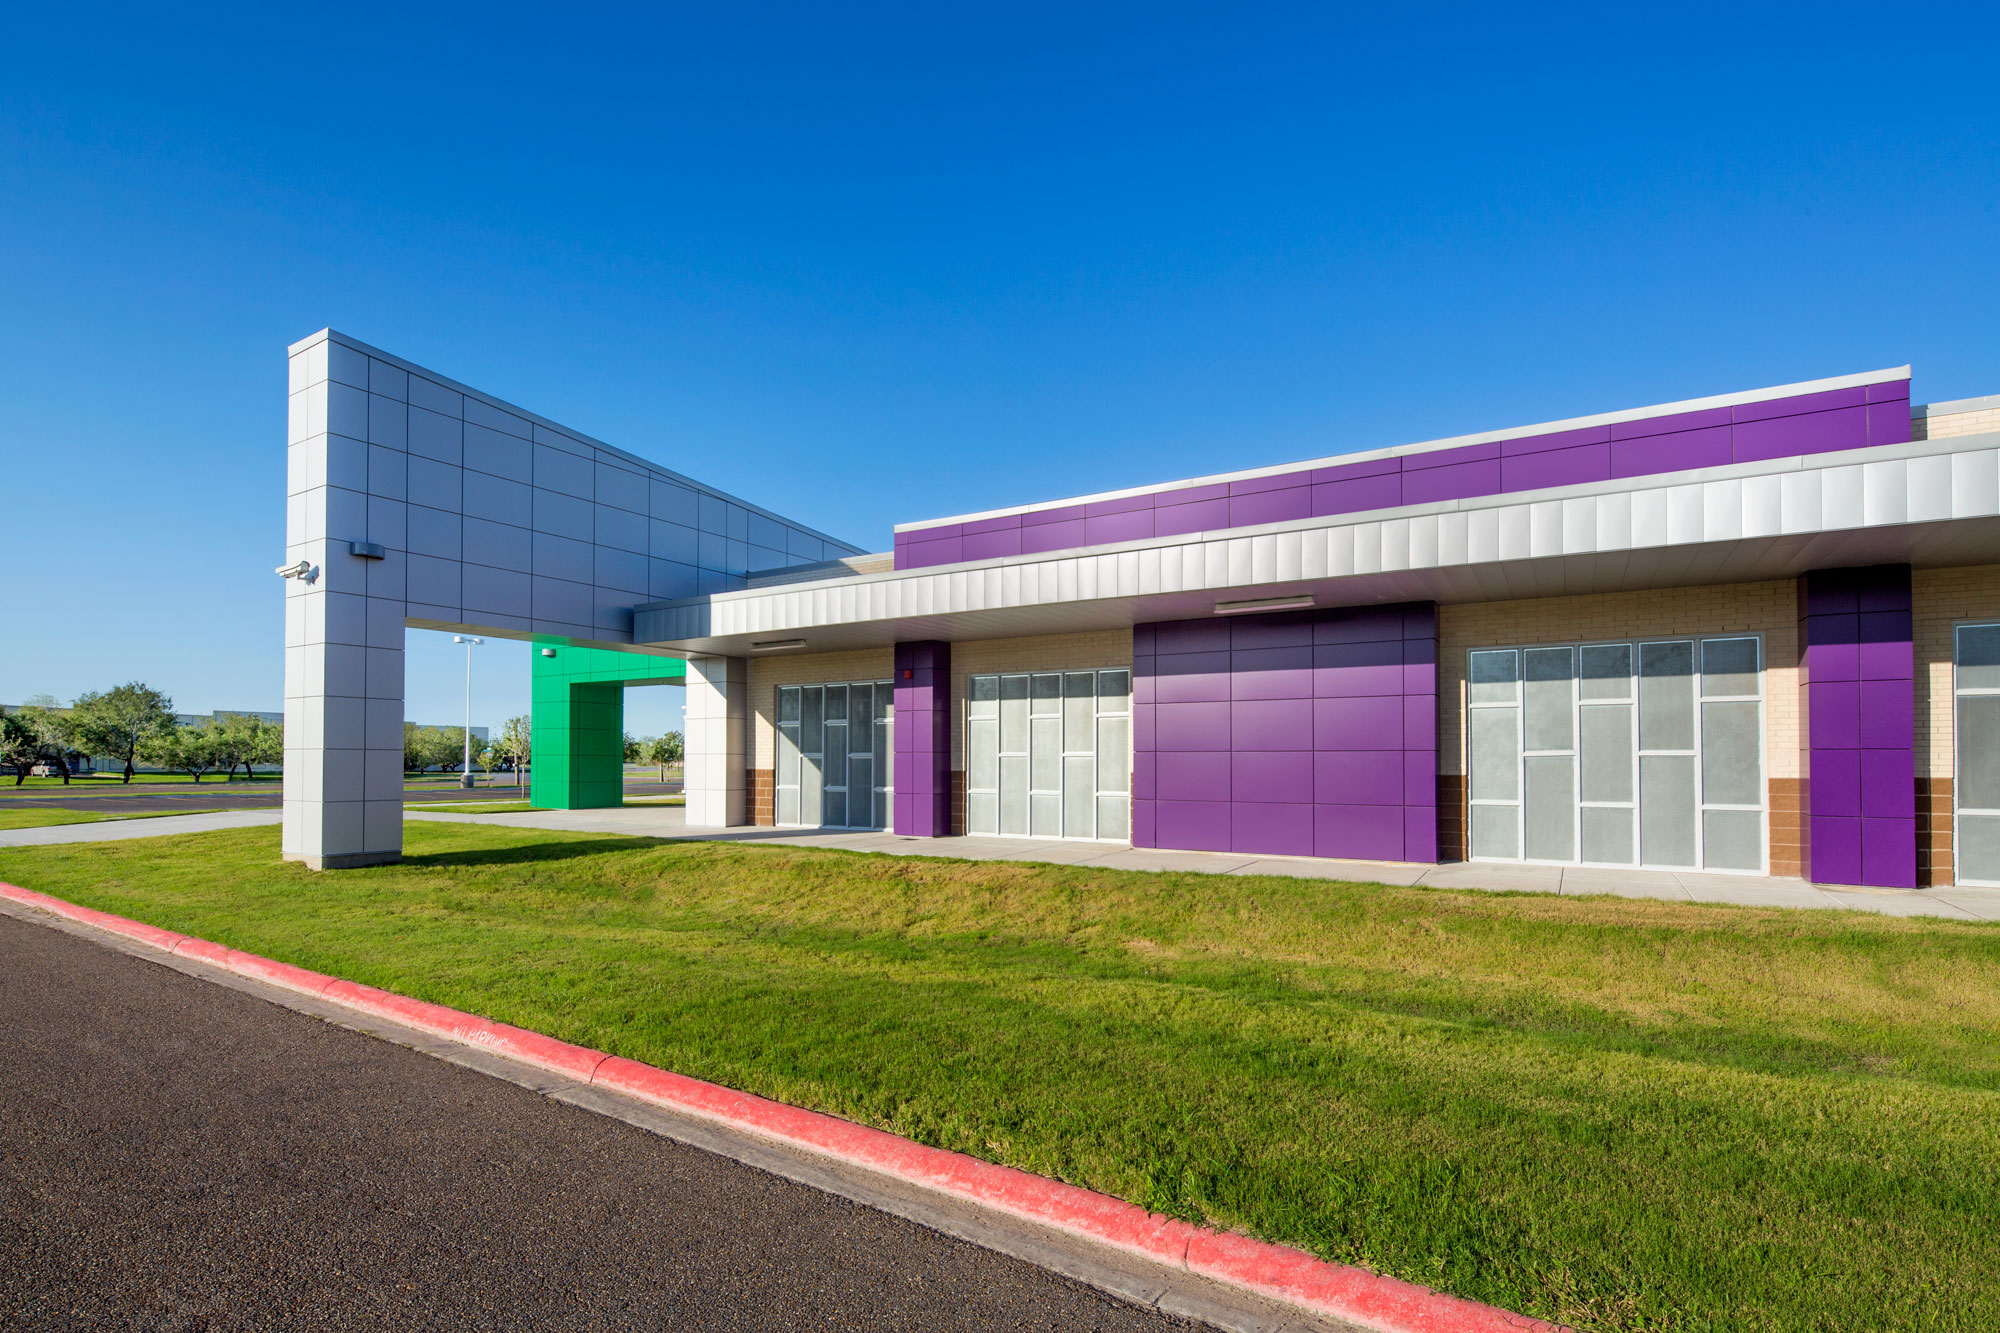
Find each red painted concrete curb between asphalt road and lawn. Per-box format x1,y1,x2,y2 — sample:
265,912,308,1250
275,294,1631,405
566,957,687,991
0,883,1566,1333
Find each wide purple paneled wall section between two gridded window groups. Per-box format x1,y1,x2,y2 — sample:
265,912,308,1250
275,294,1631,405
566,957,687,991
1132,602,1438,861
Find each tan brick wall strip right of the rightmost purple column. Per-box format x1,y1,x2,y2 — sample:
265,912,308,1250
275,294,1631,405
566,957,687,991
1910,560,2000,885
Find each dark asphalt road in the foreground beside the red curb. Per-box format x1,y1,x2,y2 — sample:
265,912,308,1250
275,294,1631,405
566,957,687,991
0,917,1200,1333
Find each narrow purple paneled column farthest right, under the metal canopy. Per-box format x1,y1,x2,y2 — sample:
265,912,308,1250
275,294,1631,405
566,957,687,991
1798,564,1916,889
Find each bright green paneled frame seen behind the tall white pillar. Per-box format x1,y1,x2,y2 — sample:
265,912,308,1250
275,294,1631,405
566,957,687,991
528,644,688,811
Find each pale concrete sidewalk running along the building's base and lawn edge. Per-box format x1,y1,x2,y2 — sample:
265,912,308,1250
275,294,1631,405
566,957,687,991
0,792,2000,921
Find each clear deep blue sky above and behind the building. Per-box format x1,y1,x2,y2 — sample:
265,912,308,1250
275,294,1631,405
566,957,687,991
0,4,2000,731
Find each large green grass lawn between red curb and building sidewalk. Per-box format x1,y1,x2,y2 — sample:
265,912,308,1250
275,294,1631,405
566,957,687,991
0,823,2000,1331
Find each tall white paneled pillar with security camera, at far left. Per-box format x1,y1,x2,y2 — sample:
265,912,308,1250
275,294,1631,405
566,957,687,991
284,340,406,871
